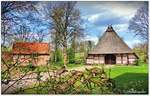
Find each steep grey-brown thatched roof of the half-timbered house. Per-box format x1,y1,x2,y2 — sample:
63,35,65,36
89,26,133,54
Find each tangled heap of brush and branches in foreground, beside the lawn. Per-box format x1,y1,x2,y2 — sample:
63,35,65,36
16,67,115,94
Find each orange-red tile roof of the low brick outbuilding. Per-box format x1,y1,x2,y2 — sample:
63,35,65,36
12,42,50,54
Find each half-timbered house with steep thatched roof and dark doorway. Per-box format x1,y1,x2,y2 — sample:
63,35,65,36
86,26,138,64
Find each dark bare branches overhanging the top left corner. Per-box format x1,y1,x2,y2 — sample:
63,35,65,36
1,1,37,22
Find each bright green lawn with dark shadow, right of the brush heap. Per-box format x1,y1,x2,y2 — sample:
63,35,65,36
107,64,148,94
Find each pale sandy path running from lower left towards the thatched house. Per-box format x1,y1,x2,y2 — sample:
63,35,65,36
1,65,114,94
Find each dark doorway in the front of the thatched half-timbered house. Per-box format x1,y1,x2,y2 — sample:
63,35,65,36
105,54,116,64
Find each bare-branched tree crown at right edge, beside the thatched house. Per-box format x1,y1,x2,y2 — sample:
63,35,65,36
128,3,149,42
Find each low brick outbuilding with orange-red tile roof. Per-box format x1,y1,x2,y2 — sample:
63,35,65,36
12,42,50,66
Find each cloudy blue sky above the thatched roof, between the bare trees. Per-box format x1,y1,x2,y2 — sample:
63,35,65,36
76,1,144,48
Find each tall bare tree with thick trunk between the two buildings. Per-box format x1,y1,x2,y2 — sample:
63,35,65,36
49,2,80,67
